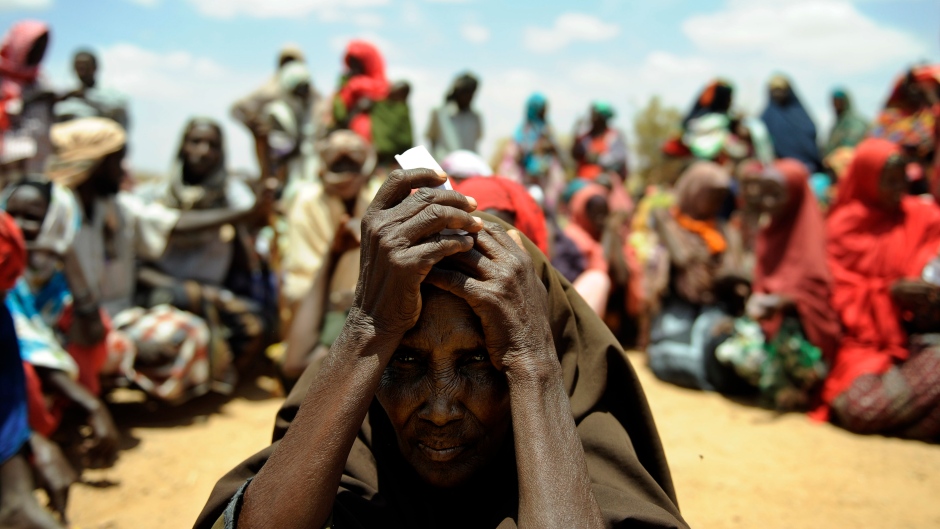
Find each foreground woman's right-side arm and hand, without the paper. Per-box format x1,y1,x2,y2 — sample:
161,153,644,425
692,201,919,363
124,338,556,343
428,223,604,528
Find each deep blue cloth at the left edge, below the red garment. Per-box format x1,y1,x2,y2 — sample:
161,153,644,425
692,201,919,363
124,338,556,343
0,303,30,464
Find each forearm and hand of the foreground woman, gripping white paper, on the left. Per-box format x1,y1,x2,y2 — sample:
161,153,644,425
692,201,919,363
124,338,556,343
238,169,480,529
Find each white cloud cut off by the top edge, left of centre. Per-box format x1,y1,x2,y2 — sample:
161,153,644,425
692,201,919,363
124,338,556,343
189,0,389,18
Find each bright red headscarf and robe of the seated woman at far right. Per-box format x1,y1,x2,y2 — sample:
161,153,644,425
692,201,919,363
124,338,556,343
823,139,940,416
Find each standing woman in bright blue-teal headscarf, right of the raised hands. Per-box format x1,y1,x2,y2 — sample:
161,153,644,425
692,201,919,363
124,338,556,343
498,92,565,210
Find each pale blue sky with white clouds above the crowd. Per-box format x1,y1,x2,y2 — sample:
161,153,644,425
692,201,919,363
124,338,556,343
0,0,940,171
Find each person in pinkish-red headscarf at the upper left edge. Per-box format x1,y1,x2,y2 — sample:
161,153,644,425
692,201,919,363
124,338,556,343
0,20,55,172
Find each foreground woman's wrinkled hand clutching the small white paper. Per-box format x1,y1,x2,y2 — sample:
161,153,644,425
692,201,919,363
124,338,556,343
350,169,482,339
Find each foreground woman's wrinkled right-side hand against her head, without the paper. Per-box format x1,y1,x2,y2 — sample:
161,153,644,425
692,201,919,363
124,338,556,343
427,222,557,373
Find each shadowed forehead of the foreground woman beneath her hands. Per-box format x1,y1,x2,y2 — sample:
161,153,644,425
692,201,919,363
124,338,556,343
402,285,483,351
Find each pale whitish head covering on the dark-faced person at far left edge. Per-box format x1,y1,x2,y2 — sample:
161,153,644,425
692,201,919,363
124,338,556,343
0,181,82,255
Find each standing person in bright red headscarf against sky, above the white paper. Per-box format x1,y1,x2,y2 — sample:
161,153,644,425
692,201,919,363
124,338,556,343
333,40,389,143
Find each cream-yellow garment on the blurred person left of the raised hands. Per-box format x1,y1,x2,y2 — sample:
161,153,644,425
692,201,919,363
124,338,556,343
283,178,381,304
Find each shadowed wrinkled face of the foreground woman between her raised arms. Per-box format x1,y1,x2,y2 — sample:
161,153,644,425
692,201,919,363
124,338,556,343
376,286,512,488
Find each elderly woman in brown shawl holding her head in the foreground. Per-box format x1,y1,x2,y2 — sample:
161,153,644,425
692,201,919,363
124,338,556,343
196,169,685,528
